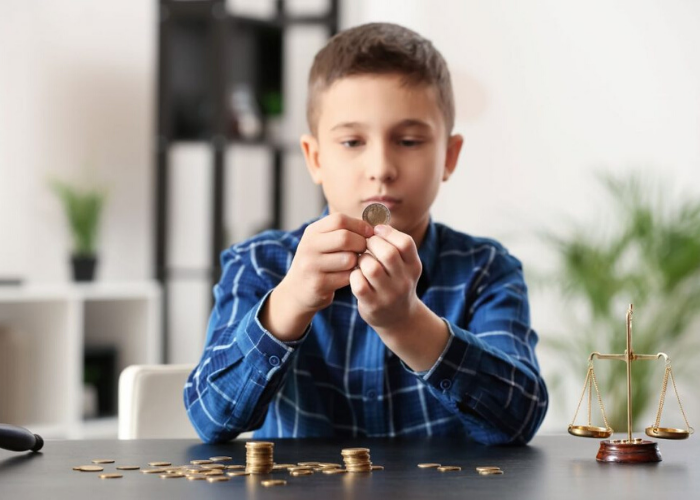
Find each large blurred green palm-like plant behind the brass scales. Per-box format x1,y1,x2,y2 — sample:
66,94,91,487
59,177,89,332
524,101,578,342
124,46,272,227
543,175,700,432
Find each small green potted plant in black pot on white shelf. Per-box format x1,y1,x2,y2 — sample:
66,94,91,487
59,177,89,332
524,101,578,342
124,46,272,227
51,181,106,281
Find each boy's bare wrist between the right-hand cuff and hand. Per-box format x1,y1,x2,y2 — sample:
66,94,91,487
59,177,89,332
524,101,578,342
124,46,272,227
376,302,450,372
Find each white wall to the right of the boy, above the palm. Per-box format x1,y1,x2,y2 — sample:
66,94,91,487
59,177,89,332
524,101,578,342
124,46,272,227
345,0,700,432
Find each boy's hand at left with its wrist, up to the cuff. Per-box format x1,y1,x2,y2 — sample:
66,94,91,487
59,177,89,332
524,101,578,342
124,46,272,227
261,214,374,341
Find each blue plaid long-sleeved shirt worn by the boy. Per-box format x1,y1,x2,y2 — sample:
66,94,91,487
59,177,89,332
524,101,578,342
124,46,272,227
184,215,548,444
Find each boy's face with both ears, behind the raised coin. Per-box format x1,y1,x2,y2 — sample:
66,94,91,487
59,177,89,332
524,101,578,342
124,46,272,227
301,75,462,243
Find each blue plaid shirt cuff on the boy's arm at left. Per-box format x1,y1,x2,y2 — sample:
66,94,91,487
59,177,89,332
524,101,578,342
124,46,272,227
238,291,311,380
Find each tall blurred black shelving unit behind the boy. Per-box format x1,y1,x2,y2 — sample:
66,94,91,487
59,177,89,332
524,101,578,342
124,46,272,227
155,0,339,362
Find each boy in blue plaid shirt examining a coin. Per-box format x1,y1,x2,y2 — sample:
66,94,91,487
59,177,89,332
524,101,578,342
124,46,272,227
185,23,547,444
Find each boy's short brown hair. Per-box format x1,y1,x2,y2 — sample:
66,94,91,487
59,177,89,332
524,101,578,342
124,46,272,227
306,23,455,135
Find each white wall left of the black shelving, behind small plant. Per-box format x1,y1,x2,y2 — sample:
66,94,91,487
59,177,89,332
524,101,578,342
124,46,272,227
0,0,156,282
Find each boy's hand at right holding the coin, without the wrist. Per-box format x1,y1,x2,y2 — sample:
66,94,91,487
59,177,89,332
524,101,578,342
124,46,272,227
350,225,422,330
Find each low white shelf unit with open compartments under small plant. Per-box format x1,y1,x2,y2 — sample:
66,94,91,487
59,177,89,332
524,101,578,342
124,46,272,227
0,282,161,438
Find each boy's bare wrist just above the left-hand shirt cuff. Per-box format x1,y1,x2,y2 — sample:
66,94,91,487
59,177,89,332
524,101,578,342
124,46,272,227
260,281,316,342
